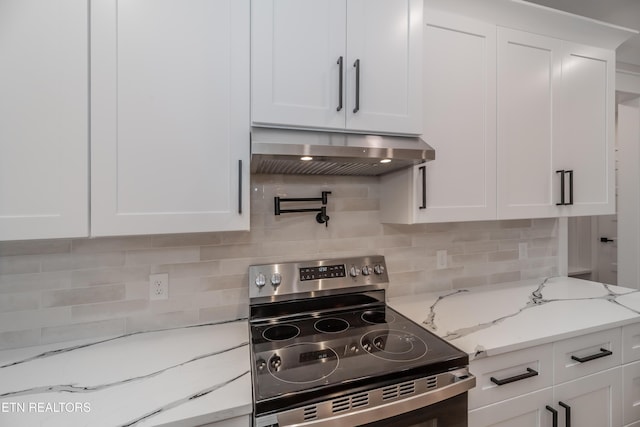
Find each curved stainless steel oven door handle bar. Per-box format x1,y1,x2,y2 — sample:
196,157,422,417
277,374,476,427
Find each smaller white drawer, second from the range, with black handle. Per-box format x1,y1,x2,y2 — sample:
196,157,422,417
553,328,622,384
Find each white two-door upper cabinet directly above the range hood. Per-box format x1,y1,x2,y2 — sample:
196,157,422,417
251,0,423,134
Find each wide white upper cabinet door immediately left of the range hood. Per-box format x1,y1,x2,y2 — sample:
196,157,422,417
91,0,250,236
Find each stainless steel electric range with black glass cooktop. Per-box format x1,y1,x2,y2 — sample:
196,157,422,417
249,256,475,427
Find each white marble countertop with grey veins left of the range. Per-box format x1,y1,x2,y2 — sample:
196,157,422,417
0,321,252,427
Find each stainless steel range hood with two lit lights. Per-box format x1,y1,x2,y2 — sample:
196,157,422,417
251,127,435,176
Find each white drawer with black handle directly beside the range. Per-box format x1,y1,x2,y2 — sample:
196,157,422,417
469,344,553,410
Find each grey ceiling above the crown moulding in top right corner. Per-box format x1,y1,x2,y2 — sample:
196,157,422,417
528,0,640,66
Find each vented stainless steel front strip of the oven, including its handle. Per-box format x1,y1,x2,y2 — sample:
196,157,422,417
255,368,476,427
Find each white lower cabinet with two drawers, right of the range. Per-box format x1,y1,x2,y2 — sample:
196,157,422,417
469,328,624,427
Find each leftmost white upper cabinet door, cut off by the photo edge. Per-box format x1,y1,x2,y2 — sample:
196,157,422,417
0,0,89,240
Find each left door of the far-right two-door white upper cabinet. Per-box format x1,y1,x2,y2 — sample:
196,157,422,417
497,28,561,219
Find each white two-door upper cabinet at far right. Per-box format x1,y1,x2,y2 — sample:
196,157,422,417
498,28,615,219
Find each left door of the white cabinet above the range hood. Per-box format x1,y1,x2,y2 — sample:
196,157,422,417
251,0,347,129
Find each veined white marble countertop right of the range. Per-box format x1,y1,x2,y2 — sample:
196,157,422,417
388,277,640,360
